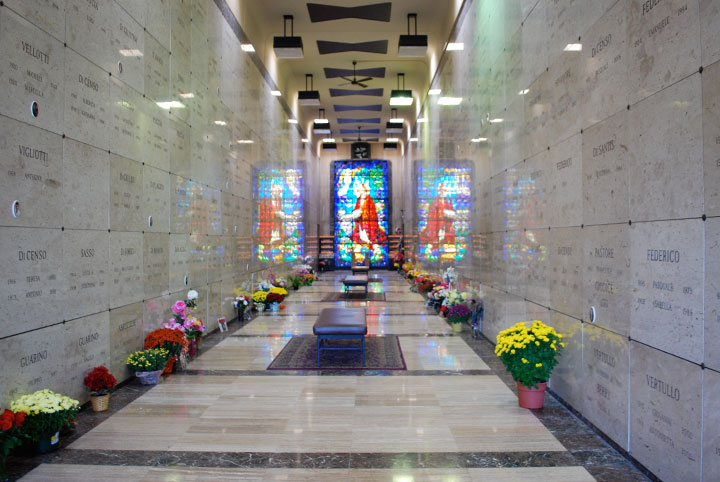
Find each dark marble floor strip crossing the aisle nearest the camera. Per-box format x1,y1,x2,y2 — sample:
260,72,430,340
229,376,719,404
31,449,579,469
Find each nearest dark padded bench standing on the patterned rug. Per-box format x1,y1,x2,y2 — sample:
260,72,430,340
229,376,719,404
313,308,367,367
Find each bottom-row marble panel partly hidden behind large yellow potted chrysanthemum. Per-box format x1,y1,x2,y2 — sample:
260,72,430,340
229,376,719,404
541,311,585,407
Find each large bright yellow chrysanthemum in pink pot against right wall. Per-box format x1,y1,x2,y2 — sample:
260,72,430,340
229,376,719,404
495,320,565,408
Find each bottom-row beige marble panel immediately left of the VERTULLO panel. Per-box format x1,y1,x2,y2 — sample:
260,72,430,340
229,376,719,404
576,322,630,450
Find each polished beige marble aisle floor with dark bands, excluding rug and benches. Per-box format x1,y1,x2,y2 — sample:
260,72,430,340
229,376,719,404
14,272,647,482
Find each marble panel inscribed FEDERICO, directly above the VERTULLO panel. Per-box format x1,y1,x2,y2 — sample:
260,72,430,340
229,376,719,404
630,219,705,363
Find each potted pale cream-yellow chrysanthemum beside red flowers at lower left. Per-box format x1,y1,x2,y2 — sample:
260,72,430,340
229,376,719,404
10,388,80,453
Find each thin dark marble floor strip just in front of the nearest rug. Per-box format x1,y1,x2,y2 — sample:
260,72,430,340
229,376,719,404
173,369,495,377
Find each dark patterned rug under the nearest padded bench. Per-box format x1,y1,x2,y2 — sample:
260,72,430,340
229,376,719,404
267,335,407,370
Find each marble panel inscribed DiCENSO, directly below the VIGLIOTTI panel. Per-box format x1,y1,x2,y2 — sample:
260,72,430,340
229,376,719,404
0,228,63,338
